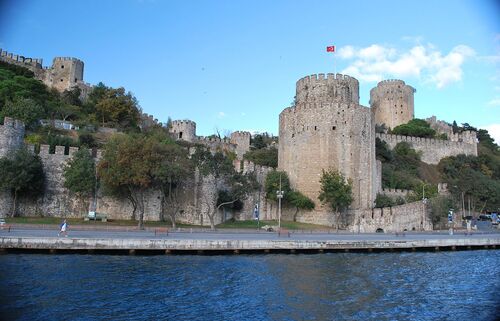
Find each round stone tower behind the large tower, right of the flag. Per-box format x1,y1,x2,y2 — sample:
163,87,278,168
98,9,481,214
370,80,415,128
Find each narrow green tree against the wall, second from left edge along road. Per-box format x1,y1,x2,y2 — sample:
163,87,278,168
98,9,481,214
63,148,96,209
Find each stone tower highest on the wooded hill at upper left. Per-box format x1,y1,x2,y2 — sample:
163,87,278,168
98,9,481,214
44,57,83,91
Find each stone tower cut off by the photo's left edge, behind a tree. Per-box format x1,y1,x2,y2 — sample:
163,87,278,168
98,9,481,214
0,117,24,217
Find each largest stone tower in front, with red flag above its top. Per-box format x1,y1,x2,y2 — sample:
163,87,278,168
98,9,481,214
278,74,376,223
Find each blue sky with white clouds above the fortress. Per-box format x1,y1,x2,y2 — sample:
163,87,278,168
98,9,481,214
0,0,500,142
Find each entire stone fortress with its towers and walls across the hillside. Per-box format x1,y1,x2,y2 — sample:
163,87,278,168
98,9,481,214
0,50,477,232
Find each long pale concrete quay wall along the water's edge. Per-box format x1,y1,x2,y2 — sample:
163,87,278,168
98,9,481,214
0,236,500,253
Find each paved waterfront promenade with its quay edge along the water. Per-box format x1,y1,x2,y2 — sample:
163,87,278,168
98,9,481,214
0,227,500,254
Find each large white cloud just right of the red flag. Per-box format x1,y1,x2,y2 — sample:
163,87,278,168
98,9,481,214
338,44,476,88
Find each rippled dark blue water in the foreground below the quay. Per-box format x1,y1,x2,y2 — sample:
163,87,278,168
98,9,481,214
0,250,500,321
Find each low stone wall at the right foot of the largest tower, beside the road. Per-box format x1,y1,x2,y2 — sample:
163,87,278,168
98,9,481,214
350,201,432,233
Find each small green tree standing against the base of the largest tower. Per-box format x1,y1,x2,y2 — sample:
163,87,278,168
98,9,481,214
318,170,353,213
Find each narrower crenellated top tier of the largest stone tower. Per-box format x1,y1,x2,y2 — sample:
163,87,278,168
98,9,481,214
295,73,359,104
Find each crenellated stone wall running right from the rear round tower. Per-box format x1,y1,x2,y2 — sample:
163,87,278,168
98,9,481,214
376,133,477,165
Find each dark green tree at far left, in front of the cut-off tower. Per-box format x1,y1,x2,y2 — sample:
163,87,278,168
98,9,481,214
0,148,44,216
